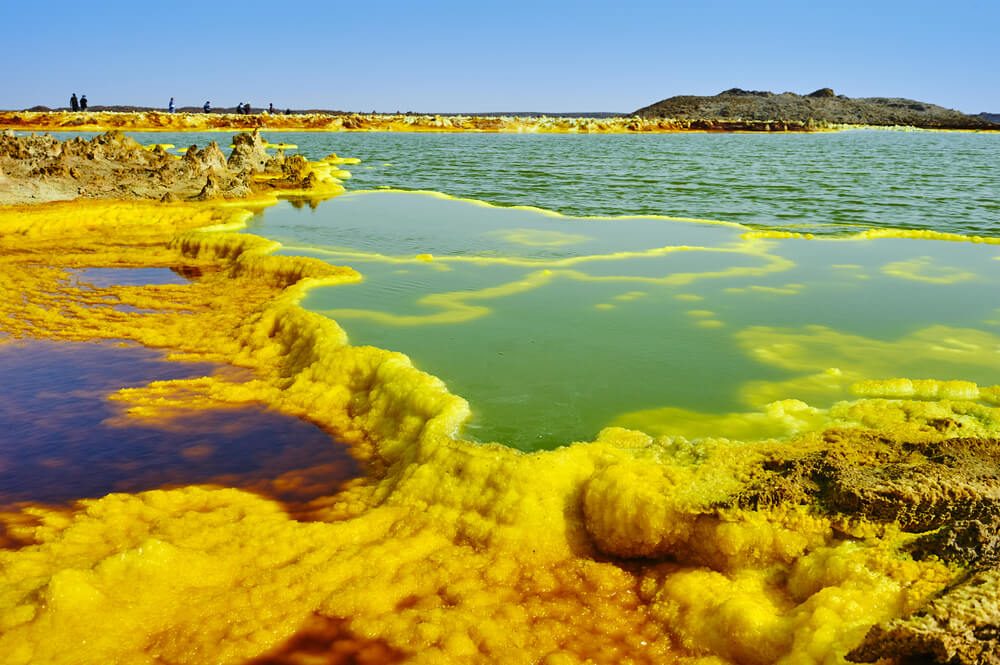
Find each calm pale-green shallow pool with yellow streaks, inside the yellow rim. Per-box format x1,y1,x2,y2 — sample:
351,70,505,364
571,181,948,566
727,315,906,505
253,192,1000,450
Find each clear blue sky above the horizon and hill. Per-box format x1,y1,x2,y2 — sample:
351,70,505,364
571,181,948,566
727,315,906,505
7,0,1000,113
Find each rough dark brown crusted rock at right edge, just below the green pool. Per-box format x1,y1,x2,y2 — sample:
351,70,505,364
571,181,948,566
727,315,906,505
728,431,1000,567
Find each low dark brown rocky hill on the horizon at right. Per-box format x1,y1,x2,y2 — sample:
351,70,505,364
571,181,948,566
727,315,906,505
635,88,1000,129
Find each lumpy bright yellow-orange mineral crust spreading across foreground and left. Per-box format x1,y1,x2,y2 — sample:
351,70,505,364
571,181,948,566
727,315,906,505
0,195,998,665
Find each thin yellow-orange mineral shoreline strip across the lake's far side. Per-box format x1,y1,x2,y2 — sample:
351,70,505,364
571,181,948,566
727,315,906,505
0,110,1000,134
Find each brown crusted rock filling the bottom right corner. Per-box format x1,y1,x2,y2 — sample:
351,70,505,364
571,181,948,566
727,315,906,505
847,569,1000,665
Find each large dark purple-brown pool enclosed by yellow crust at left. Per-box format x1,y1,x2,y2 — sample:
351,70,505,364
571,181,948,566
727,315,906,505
0,341,360,503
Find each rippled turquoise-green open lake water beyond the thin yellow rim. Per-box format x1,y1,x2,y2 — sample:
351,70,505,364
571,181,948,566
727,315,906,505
62,130,1000,236
